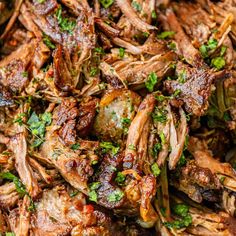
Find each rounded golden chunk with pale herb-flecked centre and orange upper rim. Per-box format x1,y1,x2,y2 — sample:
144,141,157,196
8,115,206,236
94,89,140,141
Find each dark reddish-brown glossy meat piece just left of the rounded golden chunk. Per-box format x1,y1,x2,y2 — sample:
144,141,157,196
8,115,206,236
76,97,99,137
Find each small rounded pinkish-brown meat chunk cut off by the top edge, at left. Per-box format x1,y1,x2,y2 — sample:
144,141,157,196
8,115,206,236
33,0,58,15
